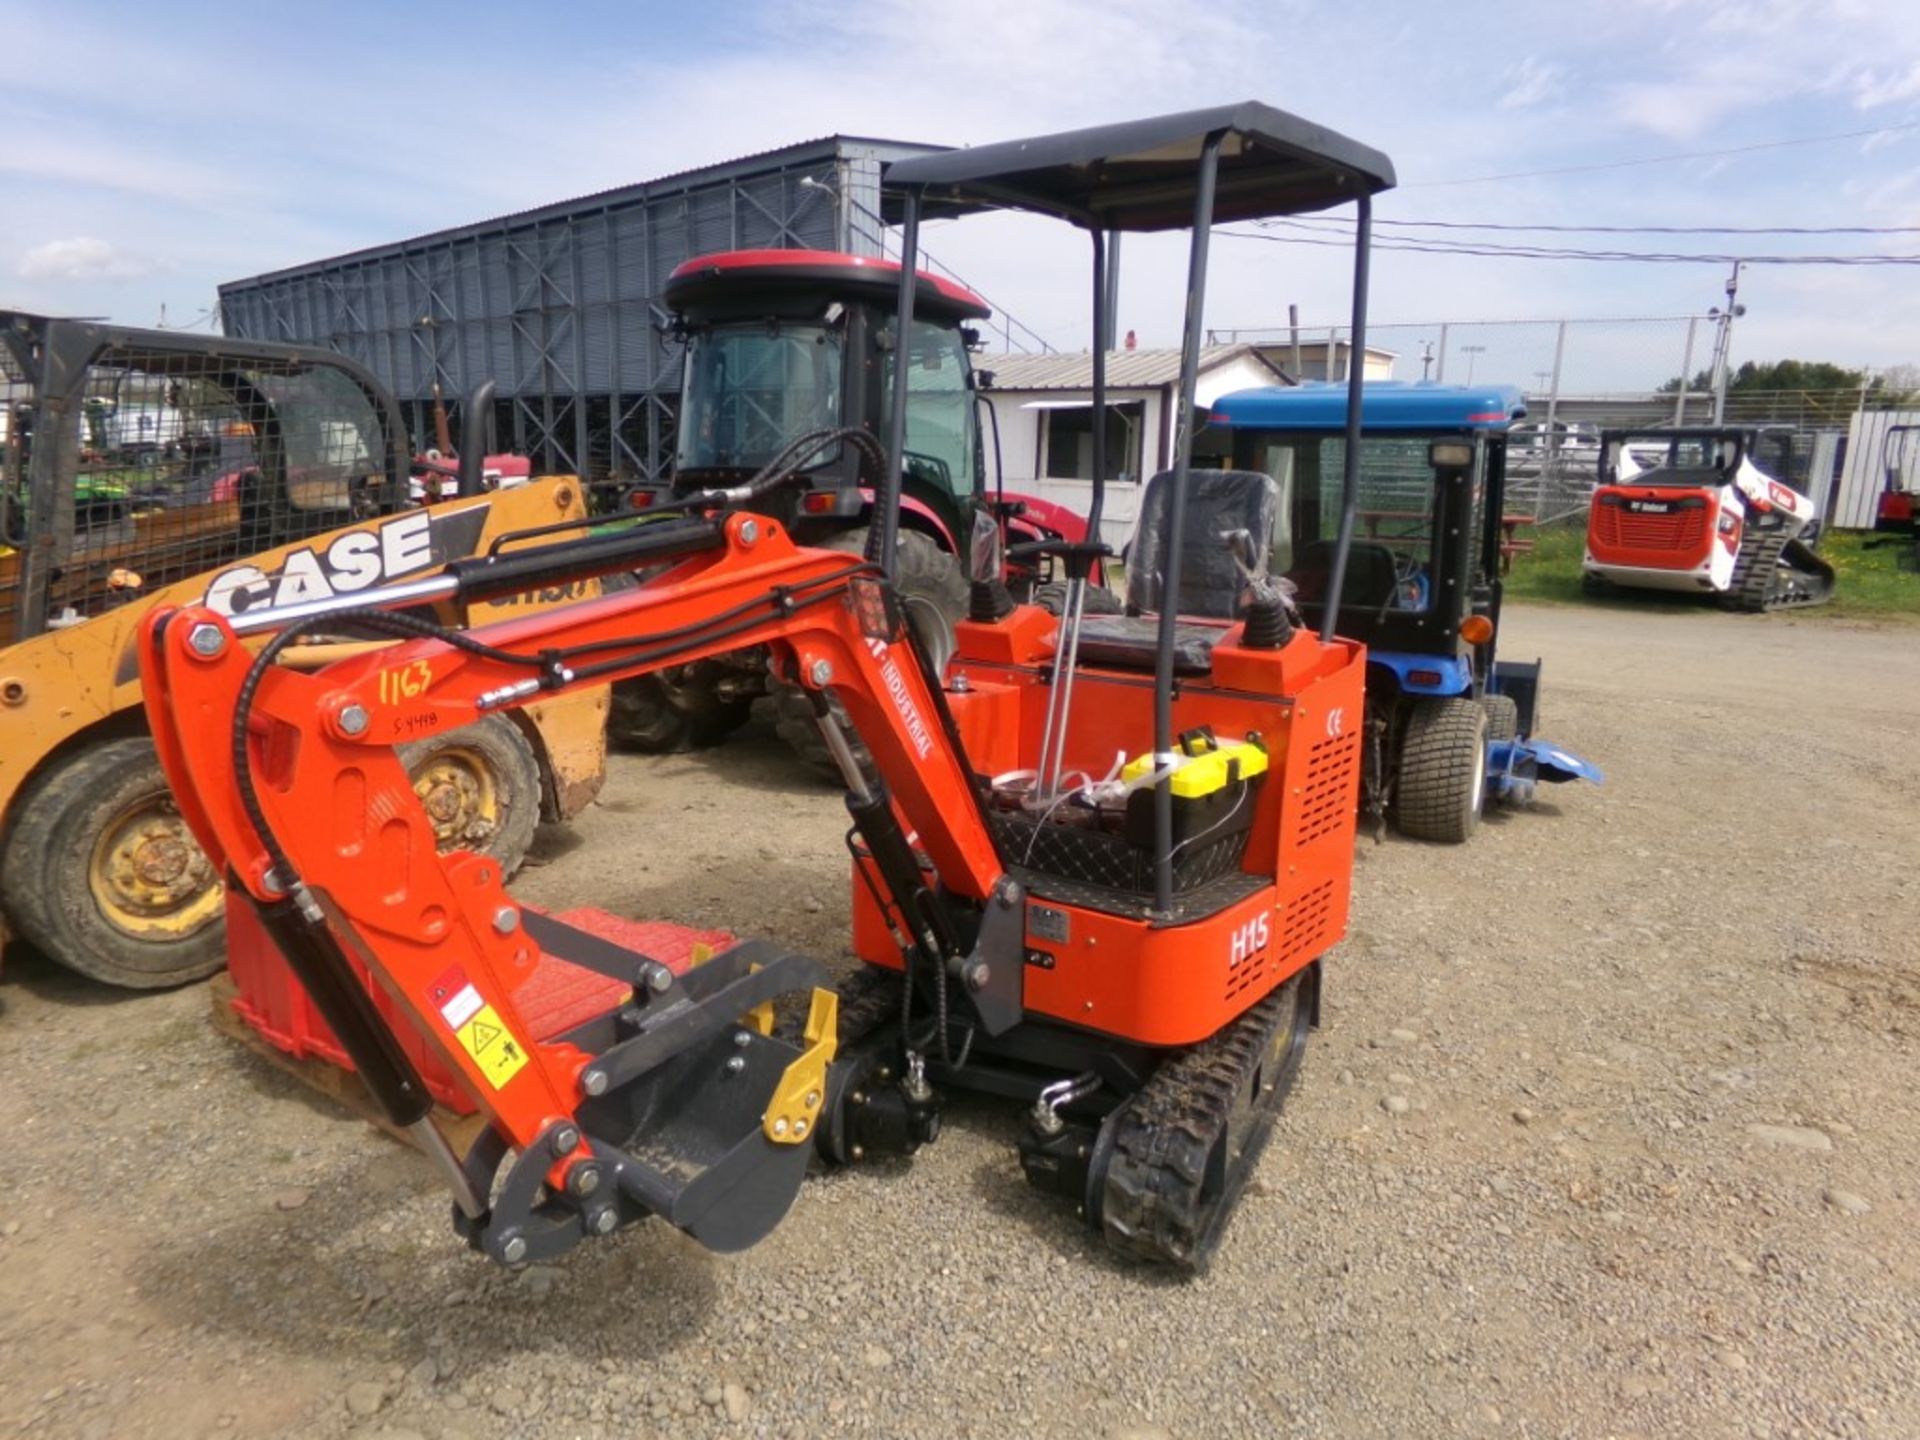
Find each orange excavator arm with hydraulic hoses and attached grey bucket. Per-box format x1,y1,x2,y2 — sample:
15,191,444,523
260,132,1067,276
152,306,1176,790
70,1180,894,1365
142,513,1018,1263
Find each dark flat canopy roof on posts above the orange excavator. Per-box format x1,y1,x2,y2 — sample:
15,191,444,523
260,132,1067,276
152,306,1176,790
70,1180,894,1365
883,100,1394,230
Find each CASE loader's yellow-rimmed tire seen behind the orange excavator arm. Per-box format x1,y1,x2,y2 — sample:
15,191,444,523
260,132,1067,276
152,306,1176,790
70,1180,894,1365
396,714,540,879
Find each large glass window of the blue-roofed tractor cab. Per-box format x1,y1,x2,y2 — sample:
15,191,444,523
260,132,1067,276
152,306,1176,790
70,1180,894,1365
1256,436,1434,614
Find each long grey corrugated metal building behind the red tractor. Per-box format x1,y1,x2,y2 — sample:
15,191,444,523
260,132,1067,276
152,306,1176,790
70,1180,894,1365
221,134,927,495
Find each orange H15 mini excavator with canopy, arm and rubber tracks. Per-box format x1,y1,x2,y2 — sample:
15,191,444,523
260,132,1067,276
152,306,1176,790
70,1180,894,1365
142,104,1392,1269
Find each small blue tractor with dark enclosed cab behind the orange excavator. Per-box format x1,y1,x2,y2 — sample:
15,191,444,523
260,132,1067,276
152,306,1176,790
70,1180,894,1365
1210,380,1601,841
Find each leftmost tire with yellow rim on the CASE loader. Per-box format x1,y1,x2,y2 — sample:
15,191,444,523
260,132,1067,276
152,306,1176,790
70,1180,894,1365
0,735,227,991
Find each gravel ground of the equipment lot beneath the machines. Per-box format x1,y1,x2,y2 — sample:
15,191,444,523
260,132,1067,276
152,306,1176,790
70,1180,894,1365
0,609,1920,1440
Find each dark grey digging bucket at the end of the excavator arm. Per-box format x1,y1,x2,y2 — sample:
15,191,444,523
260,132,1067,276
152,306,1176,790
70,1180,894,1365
455,912,837,1265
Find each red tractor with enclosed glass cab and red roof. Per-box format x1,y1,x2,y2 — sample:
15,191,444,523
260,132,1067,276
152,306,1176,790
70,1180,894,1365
612,250,1087,776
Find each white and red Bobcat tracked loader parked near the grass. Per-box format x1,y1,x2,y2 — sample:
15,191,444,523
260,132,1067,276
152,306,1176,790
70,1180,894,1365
1582,426,1834,611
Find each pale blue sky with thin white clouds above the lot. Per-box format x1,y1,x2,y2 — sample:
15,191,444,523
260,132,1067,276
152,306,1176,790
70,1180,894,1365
0,0,1920,384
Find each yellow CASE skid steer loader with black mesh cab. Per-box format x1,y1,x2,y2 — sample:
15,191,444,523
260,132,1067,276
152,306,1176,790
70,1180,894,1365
0,313,607,989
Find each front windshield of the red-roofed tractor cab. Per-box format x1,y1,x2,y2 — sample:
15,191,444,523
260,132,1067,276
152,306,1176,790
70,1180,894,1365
674,323,845,470
